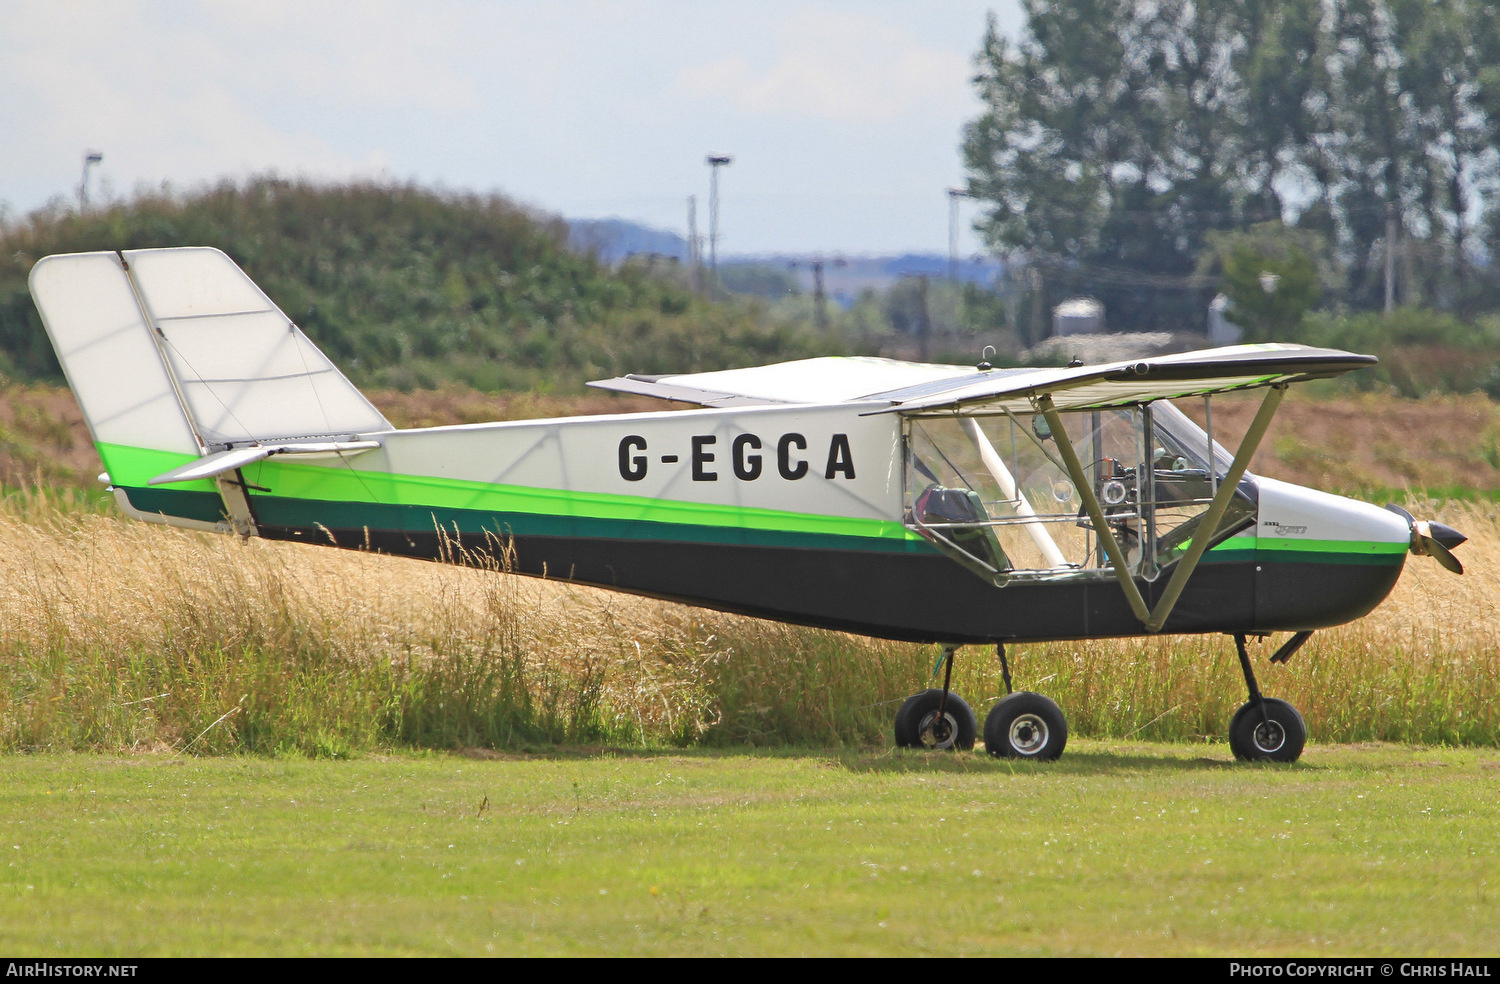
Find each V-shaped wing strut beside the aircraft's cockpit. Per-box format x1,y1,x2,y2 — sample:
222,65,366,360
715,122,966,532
1037,383,1287,632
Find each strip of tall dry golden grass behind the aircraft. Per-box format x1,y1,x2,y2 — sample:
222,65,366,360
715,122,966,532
0,492,1500,756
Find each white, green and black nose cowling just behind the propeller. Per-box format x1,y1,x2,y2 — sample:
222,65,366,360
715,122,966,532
1256,477,1412,632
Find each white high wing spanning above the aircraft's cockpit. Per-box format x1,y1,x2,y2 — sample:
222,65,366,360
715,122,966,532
590,344,1377,414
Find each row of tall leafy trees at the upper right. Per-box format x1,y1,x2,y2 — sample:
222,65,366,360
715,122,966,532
963,0,1500,330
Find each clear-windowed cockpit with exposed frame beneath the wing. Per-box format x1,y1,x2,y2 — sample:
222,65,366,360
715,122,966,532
903,401,1256,585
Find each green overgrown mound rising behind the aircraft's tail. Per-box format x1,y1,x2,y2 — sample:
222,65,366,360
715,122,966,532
0,179,828,392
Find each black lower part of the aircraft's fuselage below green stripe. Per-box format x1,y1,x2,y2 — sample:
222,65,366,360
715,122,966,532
260,525,1401,644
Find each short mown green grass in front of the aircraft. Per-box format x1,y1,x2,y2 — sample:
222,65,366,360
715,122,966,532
0,740,1500,956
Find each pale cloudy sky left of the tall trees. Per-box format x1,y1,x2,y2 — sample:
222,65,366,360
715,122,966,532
0,0,1020,254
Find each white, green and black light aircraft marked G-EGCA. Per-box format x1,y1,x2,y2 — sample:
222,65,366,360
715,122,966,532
30,248,1464,761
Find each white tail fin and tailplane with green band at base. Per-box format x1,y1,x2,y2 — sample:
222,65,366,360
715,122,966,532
30,246,392,533
